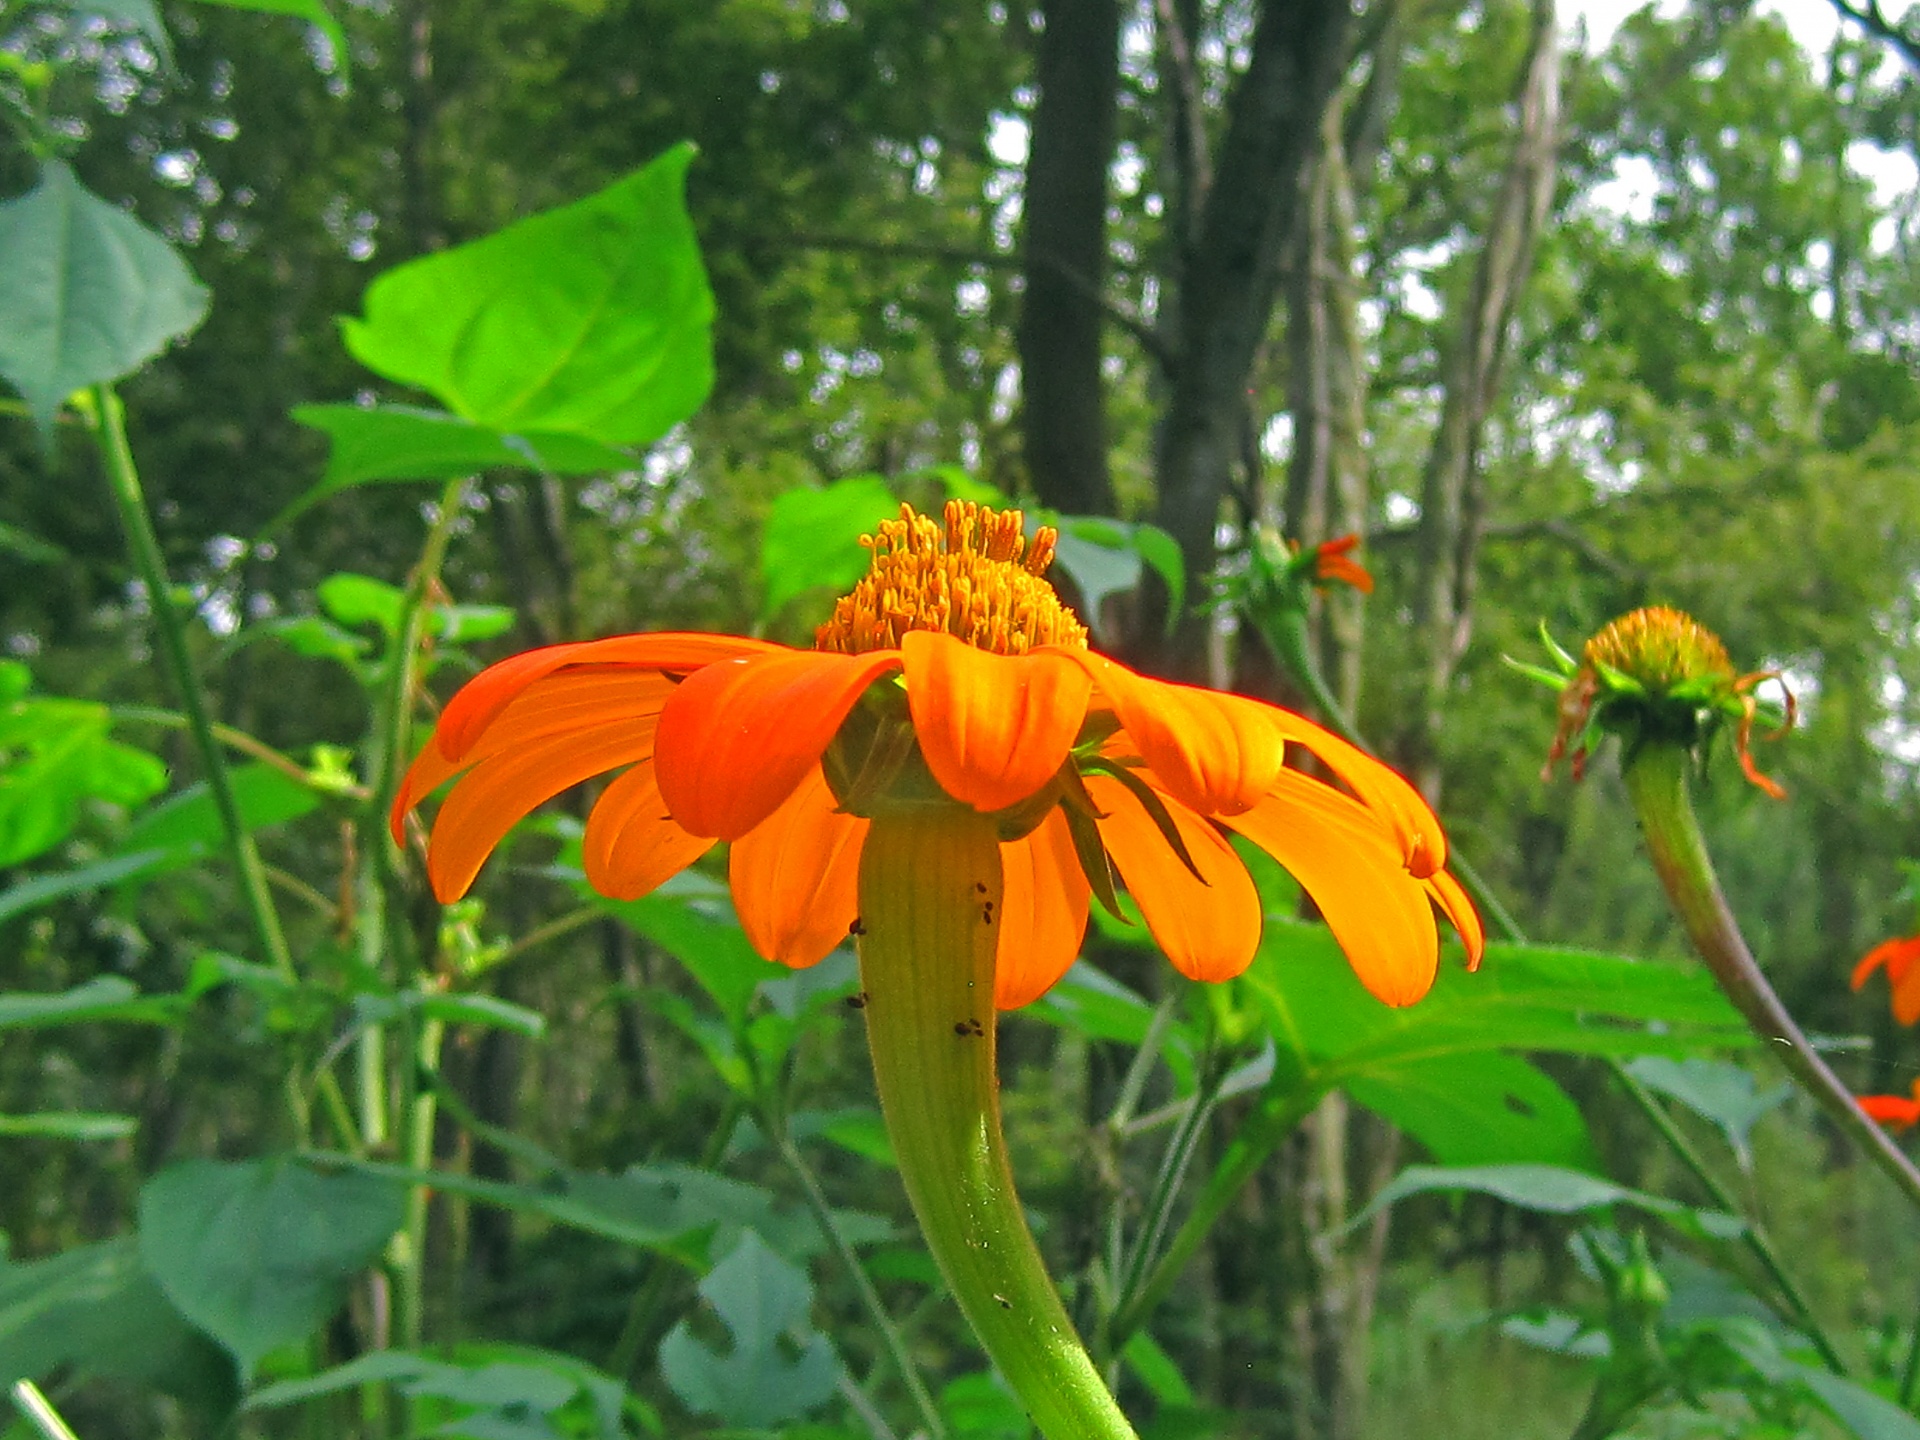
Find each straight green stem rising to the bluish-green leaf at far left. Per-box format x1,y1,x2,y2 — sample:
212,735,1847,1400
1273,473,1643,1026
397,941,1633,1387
86,386,355,1148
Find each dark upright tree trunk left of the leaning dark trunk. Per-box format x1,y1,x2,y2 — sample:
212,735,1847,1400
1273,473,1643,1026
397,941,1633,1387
1020,0,1119,515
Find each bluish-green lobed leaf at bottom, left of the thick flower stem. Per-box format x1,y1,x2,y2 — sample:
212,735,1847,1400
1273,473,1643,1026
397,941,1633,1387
660,1231,839,1427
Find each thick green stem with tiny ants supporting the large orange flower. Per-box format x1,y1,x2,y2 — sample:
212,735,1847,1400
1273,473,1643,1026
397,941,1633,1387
860,803,1137,1440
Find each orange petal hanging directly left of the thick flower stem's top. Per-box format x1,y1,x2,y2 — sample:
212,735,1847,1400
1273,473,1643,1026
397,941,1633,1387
728,766,872,968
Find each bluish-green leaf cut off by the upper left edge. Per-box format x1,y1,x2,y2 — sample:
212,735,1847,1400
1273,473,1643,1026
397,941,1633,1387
0,159,207,434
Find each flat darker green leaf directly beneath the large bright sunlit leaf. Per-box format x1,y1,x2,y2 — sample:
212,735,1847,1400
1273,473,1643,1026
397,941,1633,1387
267,405,636,532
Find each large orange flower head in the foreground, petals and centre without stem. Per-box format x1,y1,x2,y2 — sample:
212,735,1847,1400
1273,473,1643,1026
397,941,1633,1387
394,503,1482,1008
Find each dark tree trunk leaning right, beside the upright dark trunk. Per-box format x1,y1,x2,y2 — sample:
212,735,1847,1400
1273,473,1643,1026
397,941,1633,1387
1156,0,1352,674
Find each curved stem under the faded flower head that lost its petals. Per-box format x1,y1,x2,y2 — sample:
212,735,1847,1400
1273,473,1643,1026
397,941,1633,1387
1626,741,1920,1206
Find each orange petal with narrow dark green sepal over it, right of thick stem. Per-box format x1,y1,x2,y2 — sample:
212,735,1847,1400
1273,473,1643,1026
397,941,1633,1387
1087,776,1260,979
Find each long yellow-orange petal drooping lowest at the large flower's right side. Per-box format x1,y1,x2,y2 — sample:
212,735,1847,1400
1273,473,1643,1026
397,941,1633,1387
1227,770,1440,1004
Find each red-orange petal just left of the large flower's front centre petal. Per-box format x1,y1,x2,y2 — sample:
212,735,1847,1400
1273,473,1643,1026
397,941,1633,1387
655,651,900,839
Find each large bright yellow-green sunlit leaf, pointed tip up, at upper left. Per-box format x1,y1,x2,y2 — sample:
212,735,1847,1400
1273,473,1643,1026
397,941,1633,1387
344,144,712,445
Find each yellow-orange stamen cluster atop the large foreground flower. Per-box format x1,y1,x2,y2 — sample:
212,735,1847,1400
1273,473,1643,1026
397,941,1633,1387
814,499,1087,655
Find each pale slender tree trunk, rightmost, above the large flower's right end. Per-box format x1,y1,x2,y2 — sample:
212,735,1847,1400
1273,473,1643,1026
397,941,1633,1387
1407,0,1559,803
